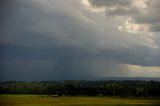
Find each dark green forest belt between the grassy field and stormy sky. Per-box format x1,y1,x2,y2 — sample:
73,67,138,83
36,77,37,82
0,80,160,97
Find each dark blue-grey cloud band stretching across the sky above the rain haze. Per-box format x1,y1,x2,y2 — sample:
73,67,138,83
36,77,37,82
0,45,160,66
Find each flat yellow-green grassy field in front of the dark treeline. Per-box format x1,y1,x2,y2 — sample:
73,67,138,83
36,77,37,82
0,95,160,106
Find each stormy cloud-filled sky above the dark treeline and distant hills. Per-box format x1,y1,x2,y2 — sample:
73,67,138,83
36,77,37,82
0,0,160,81
